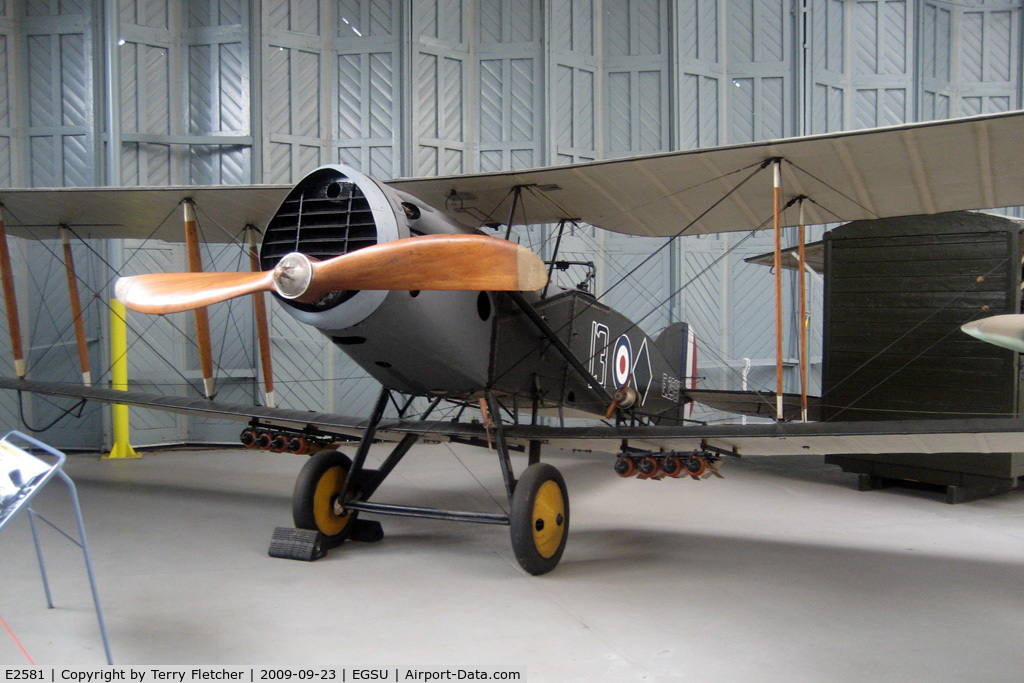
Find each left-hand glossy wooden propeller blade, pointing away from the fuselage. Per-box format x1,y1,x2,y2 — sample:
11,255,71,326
115,270,273,315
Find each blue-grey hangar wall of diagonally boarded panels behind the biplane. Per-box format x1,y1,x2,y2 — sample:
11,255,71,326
0,0,1022,446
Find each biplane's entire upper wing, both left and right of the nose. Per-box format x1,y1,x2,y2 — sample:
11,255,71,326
0,112,1024,242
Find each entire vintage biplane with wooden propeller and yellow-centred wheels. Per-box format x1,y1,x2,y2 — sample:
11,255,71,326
0,112,1024,574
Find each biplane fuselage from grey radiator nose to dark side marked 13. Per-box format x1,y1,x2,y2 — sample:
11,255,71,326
260,166,686,416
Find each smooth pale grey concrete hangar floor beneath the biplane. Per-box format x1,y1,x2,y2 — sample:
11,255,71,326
0,445,1024,682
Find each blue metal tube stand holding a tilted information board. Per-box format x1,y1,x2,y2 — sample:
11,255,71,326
0,431,114,665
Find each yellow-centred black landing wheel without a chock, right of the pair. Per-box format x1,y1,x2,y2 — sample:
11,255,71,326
509,463,569,577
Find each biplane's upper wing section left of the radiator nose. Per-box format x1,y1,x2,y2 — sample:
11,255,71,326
0,185,291,242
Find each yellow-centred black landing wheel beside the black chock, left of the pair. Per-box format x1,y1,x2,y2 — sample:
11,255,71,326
292,451,356,545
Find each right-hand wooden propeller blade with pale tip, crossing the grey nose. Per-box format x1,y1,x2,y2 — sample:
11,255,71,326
299,234,548,302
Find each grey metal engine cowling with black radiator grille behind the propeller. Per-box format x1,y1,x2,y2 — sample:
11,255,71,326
260,166,496,395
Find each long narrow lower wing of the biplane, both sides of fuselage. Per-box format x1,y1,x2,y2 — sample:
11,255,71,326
0,377,1024,456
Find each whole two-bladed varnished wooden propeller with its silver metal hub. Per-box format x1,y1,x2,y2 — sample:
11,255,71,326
116,234,548,314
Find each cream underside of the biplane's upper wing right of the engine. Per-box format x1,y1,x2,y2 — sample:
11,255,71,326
388,112,1024,237
